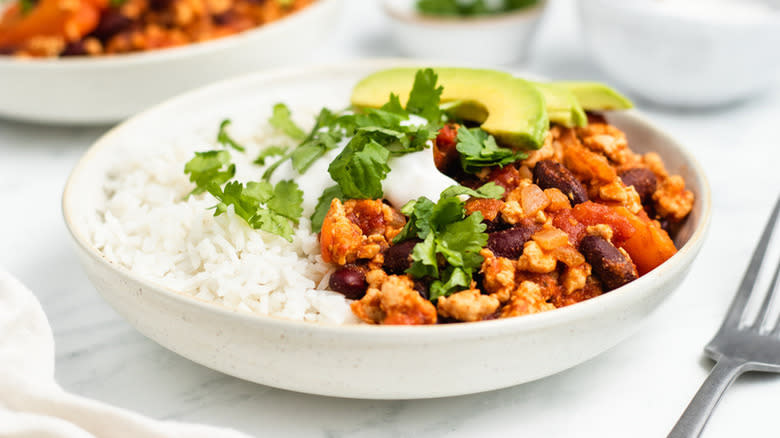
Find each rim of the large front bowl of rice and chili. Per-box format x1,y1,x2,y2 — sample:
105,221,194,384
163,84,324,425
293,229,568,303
62,58,712,341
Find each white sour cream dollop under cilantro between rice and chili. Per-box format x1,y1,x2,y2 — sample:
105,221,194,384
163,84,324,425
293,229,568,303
271,116,458,216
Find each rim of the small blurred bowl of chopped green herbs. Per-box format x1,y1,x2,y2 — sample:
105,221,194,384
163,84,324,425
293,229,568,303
382,0,548,28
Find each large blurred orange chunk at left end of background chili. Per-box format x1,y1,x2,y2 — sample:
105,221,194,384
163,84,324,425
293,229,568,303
0,0,104,46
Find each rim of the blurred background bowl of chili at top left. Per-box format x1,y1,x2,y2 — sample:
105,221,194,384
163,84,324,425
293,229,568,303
0,0,343,69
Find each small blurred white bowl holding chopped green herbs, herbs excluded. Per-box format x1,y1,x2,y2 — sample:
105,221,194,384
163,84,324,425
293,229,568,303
383,0,547,65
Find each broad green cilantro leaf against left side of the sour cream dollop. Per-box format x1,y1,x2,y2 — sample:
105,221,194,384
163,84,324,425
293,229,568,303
328,132,390,199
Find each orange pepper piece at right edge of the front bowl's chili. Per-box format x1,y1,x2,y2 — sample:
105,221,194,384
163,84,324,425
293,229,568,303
615,207,677,275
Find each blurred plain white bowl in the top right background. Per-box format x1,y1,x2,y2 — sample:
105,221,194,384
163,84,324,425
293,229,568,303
577,0,780,107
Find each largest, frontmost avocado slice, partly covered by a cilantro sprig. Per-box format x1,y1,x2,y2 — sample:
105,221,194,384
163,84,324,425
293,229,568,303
351,67,549,149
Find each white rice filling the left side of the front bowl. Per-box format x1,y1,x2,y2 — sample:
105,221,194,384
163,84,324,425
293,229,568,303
91,116,357,324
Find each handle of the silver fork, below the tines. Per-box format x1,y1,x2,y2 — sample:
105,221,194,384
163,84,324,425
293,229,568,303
668,357,747,438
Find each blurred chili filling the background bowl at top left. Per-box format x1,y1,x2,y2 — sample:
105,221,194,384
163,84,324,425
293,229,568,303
0,0,315,57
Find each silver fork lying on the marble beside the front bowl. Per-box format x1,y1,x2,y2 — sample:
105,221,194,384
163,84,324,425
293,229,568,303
669,198,780,438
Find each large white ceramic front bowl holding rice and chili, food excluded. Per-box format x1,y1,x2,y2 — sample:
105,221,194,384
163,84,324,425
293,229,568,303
63,61,710,399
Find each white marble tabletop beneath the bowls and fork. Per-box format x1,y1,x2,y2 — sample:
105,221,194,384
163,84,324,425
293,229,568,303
0,0,780,437
